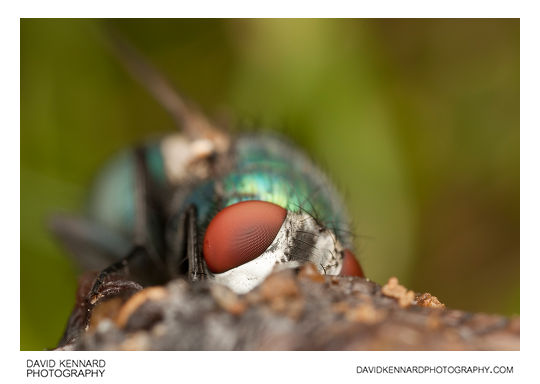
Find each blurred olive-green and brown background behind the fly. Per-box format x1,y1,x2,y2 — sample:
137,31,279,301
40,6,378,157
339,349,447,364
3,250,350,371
20,19,519,350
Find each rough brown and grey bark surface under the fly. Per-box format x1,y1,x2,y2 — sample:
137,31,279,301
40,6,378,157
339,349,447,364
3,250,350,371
54,265,520,350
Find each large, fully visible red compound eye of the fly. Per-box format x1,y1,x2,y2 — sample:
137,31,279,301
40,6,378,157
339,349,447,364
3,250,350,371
203,200,287,273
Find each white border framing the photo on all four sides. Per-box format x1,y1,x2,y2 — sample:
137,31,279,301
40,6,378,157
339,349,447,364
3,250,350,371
5,0,540,383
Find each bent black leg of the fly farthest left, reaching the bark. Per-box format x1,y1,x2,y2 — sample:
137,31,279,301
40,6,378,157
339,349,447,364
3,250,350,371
87,147,162,306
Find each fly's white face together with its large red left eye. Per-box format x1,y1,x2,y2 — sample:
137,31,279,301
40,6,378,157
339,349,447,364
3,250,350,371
207,200,344,293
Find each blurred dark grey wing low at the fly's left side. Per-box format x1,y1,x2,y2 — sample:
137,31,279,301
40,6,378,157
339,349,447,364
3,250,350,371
49,215,131,270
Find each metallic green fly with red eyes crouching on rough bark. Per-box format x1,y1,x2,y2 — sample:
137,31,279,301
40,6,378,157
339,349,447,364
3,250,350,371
53,33,364,342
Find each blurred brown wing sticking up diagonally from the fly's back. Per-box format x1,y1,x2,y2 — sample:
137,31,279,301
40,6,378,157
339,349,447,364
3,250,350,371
100,24,228,147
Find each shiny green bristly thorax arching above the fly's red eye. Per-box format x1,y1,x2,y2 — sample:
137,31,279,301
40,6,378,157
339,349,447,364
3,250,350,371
219,135,351,246
